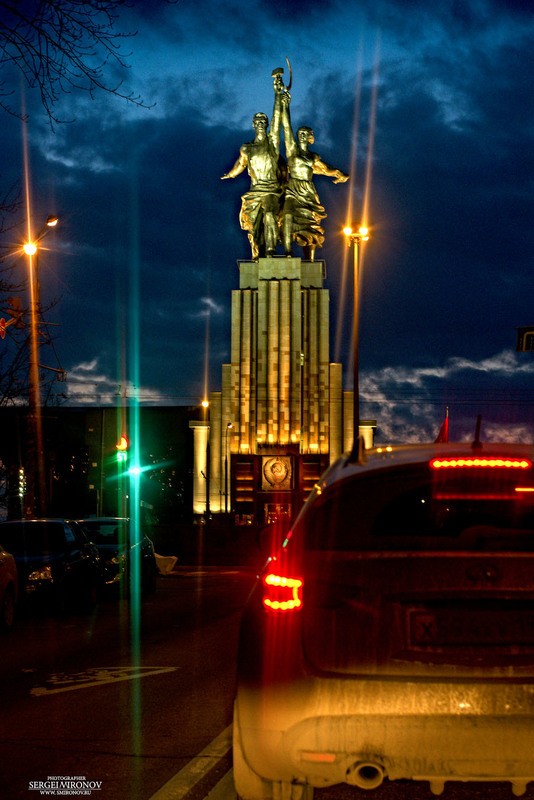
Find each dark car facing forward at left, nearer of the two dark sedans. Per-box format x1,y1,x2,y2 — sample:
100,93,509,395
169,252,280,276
0,519,102,611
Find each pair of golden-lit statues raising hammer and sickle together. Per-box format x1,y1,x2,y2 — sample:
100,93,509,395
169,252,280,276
221,59,349,261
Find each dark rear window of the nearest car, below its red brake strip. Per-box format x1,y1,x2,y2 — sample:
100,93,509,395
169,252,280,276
304,465,534,551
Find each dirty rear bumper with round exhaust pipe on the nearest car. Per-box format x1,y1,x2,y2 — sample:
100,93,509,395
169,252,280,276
236,679,534,795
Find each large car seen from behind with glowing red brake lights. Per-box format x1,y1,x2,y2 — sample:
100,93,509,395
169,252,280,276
237,442,534,800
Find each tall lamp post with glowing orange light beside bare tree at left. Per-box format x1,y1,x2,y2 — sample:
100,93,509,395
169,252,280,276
22,215,59,516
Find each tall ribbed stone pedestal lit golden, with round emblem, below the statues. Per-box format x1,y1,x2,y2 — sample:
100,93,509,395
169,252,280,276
193,256,374,524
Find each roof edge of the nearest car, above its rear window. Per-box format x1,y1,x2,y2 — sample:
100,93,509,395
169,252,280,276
317,442,534,490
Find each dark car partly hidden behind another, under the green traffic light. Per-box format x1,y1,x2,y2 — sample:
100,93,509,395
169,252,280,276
79,517,158,594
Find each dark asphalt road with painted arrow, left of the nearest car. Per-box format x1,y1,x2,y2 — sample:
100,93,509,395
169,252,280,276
0,568,254,800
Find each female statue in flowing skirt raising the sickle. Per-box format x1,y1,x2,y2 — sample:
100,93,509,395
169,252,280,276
281,92,349,261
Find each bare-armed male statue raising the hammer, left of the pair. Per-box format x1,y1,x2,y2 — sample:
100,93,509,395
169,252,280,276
221,73,285,260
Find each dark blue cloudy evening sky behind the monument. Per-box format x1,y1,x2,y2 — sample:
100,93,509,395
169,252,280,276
0,0,534,441
